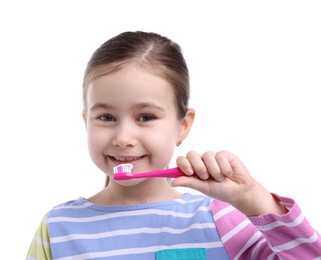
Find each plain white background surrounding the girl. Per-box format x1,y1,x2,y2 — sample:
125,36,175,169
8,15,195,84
0,0,321,259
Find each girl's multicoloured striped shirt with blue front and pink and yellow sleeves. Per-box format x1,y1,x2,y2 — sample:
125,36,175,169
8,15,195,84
27,193,321,260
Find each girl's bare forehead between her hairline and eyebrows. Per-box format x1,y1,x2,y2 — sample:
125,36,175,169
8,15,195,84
87,65,175,108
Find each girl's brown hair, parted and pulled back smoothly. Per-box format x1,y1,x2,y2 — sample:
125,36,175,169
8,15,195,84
83,31,190,186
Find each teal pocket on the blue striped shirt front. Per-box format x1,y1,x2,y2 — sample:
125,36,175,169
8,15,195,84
156,248,207,260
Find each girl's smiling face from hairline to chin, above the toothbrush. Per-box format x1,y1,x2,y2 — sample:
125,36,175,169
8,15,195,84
84,66,186,181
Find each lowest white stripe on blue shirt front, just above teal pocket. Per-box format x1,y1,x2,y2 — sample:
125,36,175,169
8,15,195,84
57,242,222,260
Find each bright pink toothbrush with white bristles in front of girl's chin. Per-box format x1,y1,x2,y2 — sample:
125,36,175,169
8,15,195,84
114,163,194,180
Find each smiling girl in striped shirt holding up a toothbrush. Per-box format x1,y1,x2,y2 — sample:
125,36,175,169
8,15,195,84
27,32,321,260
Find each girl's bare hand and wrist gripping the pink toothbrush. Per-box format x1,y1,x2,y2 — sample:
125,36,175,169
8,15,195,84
172,151,286,216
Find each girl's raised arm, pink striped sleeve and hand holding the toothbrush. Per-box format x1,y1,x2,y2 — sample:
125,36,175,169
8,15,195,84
172,151,321,259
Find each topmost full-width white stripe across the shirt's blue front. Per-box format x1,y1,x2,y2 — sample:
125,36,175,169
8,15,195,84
47,206,208,223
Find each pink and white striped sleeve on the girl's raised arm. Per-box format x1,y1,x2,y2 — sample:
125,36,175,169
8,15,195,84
212,194,321,260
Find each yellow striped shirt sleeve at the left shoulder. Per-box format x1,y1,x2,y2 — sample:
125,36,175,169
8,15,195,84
26,215,52,260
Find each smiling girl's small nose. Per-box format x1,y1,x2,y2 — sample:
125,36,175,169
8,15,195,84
112,122,137,148
